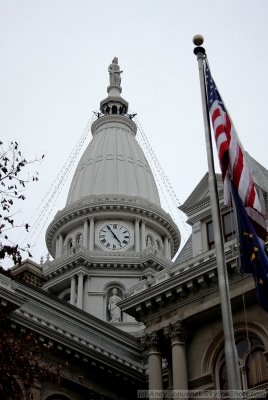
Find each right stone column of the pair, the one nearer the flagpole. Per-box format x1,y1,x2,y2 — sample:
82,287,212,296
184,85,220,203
164,321,188,399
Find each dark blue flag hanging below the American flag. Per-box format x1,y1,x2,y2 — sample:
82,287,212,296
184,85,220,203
232,184,268,311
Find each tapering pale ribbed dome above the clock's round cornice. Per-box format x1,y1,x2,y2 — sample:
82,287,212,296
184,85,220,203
67,115,160,206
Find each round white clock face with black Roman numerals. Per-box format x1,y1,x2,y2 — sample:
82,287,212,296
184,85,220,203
99,224,130,250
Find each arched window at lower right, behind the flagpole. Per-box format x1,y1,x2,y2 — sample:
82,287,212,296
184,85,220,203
218,334,268,390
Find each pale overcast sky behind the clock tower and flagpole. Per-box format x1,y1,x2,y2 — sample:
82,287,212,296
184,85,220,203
0,0,268,268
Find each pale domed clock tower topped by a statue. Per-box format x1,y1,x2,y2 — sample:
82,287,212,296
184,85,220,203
44,57,180,332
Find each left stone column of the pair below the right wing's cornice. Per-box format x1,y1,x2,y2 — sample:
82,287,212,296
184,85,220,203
144,332,163,399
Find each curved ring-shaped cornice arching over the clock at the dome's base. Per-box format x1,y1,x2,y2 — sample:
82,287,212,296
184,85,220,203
46,195,180,254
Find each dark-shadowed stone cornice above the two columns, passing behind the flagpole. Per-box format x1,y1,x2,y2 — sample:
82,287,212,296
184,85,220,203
119,250,247,323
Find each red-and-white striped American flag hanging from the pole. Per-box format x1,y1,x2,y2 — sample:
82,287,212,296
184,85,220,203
205,61,267,241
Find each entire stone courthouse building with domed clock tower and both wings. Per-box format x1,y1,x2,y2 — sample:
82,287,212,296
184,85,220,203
0,58,268,400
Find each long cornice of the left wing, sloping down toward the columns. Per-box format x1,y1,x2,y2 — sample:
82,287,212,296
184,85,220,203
0,275,143,378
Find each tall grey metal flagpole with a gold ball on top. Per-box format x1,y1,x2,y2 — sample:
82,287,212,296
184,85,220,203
193,35,241,390
